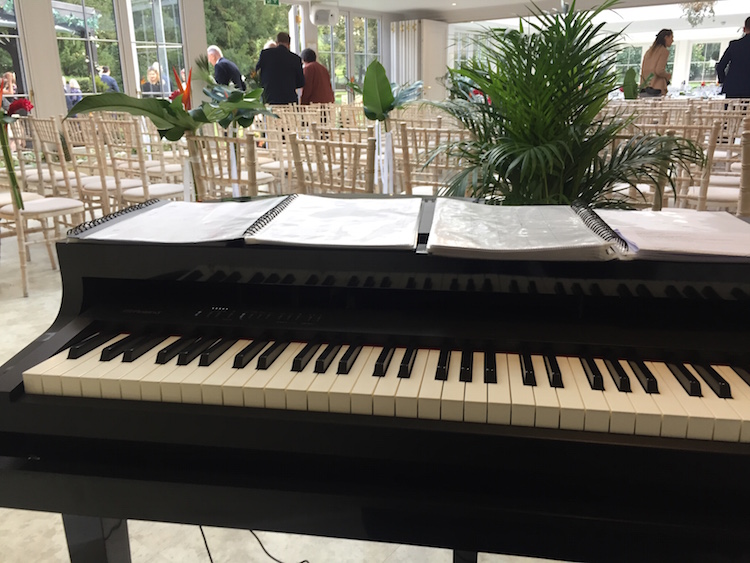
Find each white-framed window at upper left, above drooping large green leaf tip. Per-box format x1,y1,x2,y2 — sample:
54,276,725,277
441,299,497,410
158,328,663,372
52,0,122,107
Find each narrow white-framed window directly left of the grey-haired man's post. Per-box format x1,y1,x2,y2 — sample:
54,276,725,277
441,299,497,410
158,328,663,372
132,0,185,97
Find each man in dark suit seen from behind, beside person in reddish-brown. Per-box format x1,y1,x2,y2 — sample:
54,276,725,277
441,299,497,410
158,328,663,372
255,31,305,104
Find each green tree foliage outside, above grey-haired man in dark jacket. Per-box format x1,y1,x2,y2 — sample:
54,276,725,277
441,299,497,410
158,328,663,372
204,0,289,80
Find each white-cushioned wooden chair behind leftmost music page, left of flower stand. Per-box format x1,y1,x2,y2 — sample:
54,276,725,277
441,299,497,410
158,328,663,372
96,114,184,205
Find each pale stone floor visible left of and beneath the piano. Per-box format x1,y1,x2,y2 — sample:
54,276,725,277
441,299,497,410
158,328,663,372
0,231,564,563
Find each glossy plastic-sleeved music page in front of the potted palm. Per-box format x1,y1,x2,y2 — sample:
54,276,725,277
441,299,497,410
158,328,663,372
427,198,617,261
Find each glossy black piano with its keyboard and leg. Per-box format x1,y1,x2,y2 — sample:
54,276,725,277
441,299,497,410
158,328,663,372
0,198,750,563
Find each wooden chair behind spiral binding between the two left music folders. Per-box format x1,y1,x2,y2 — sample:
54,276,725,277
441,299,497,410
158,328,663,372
187,134,274,201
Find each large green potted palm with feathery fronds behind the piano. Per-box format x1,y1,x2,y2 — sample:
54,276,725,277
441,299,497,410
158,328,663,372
437,0,703,206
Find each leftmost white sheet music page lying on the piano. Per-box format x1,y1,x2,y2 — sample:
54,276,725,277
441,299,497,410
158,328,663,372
76,197,284,243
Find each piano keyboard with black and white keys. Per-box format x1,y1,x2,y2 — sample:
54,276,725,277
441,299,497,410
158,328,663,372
23,334,750,442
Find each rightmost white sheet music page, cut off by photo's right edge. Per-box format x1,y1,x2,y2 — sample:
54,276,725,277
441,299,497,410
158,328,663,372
597,208,750,262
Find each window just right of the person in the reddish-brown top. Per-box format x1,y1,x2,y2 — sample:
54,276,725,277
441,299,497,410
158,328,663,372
318,14,380,103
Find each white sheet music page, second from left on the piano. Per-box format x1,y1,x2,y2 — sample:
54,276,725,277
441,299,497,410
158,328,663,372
245,194,422,250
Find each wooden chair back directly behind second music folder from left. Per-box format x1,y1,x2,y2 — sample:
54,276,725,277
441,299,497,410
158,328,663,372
289,133,375,193
